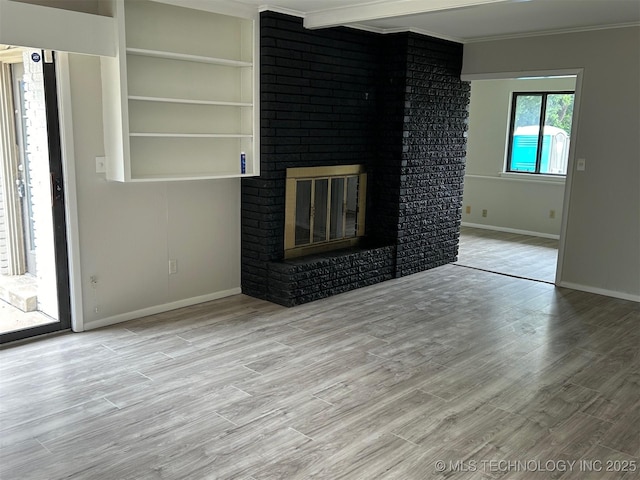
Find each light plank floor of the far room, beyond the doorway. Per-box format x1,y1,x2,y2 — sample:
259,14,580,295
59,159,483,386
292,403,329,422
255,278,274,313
456,227,558,283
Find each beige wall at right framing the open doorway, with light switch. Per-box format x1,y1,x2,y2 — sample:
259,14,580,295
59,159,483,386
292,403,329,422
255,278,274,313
462,27,640,300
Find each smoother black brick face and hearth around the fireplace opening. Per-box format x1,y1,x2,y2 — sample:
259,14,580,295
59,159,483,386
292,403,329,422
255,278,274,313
242,12,394,305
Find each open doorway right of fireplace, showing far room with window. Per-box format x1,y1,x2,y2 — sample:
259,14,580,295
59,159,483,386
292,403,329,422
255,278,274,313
457,72,580,284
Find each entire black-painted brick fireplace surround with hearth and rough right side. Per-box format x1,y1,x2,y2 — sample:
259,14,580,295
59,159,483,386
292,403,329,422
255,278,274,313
242,12,469,306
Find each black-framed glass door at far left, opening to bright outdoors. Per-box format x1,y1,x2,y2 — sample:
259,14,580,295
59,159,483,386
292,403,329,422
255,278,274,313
0,45,70,343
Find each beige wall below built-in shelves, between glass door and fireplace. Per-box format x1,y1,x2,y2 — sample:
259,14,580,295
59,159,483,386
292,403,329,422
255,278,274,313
69,55,240,328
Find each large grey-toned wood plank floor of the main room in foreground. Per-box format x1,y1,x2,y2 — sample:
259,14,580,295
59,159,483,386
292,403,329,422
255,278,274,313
0,265,640,480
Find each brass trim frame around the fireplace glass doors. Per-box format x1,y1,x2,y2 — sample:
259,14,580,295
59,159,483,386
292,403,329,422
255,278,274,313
284,165,367,258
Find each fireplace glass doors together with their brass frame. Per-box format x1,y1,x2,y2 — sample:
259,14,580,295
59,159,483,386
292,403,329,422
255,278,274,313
285,165,367,258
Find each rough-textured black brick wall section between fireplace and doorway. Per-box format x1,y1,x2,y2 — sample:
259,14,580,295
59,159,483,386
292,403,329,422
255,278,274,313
396,34,470,277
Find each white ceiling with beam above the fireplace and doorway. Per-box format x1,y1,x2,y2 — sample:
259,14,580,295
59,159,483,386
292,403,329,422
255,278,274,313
236,0,640,43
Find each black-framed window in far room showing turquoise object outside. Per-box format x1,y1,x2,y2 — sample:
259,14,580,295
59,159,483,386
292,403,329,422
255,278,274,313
507,92,574,175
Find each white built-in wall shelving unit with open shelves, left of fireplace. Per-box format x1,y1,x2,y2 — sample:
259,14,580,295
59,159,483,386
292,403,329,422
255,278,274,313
102,0,259,182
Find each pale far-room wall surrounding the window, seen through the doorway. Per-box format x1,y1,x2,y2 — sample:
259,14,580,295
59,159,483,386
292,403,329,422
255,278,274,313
462,78,575,236
